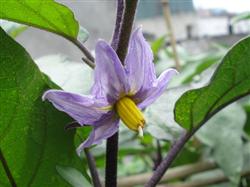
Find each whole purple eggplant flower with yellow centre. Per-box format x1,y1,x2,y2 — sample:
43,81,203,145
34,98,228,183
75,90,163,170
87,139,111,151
43,28,177,153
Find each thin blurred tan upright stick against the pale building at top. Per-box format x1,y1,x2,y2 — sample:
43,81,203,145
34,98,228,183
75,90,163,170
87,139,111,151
161,0,180,70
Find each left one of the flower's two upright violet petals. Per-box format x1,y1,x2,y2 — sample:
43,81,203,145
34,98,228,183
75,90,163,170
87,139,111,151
92,40,127,103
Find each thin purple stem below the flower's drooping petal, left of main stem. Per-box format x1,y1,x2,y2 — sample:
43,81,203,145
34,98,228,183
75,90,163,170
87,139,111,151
84,148,102,187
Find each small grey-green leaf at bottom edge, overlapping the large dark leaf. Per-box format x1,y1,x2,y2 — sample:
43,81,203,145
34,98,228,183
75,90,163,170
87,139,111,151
56,166,91,187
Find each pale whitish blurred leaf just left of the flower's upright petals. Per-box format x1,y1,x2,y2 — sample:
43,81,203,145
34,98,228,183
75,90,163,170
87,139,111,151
35,55,93,94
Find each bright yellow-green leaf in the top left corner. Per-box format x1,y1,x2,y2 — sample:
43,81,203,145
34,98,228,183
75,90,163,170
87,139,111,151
0,0,79,39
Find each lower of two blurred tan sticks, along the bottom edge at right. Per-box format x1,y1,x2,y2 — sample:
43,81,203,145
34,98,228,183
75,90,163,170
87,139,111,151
157,170,250,187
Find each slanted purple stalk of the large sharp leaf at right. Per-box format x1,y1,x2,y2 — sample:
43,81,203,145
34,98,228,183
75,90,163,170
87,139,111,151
145,129,200,187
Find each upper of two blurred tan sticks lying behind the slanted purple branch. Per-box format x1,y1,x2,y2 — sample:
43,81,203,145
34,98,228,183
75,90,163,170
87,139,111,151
118,162,216,187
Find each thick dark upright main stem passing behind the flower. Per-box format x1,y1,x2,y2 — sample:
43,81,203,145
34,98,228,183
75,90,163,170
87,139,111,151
105,0,137,187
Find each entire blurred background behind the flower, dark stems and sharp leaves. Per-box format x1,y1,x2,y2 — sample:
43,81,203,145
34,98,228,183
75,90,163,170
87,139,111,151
1,0,250,187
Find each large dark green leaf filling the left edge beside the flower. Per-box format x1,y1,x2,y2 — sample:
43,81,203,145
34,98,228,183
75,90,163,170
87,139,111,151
0,28,86,187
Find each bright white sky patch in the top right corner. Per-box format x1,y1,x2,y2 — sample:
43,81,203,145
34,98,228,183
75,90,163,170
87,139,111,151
193,0,250,13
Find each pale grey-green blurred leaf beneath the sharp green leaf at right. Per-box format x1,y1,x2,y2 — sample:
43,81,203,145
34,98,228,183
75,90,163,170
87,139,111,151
197,103,246,184
